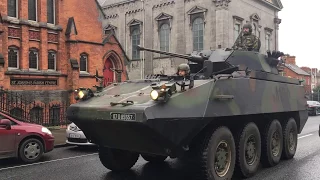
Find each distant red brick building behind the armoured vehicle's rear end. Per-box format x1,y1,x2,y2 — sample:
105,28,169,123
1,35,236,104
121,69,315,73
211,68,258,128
283,56,311,94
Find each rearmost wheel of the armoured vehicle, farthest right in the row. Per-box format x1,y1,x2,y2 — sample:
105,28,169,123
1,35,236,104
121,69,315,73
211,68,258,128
282,118,298,159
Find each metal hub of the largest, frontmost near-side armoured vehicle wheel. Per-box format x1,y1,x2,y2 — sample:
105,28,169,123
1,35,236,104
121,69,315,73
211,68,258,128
214,141,231,177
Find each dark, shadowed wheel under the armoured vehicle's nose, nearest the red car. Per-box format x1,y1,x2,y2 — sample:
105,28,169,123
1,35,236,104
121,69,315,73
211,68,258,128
99,147,139,171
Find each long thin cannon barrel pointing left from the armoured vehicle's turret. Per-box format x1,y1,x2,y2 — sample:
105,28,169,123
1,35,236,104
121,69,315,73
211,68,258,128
137,45,208,63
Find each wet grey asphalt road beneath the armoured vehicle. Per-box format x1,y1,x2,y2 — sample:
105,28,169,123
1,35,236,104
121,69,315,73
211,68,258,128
0,116,320,180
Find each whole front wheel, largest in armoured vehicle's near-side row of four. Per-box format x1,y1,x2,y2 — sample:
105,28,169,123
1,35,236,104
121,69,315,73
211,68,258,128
198,127,236,180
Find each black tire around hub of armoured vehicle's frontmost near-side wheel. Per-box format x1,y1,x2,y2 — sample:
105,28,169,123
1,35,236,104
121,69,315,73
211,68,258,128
196,127,236,180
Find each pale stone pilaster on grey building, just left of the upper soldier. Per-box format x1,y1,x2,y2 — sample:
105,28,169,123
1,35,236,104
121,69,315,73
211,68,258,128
212,0,231,48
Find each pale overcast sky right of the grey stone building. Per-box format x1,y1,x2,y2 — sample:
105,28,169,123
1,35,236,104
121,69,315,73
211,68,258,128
279,0,320,69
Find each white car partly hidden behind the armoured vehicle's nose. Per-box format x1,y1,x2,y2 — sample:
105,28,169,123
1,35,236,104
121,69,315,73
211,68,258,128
66,123,95,146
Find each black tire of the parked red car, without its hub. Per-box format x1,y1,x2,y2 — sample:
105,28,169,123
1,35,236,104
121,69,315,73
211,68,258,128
19,138,44,163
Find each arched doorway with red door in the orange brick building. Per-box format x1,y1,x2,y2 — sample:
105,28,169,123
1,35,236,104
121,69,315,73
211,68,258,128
103,52,122,87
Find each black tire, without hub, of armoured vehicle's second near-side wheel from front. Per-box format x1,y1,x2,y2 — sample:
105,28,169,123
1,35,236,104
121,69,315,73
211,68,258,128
235,122,261,178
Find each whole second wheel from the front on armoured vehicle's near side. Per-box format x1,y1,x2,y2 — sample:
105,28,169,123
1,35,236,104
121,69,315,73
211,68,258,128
235,122,261,178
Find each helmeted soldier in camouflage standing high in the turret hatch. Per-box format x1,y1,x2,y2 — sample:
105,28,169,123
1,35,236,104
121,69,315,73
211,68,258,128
233,23,261,52
